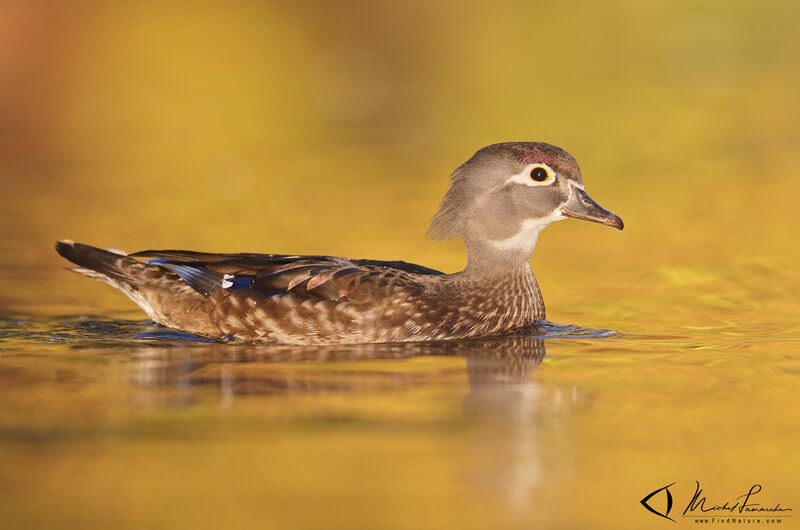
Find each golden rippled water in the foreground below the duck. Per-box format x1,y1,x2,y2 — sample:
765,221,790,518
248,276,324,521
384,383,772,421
0,308,800,528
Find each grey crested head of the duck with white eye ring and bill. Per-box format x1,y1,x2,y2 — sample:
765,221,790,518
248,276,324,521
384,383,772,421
428,142,623,256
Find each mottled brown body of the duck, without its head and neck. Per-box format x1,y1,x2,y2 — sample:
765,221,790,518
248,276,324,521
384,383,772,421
56,241,544,344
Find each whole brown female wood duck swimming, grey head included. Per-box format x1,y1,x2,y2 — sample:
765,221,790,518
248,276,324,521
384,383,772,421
56,142,623,344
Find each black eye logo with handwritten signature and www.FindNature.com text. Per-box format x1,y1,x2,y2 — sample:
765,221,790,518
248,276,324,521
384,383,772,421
639,481,792,523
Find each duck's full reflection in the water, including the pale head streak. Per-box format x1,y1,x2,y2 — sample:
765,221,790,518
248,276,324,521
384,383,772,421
125,334,575,517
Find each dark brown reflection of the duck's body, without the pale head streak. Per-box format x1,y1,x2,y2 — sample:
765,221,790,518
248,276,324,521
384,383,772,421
126,334,545,400
